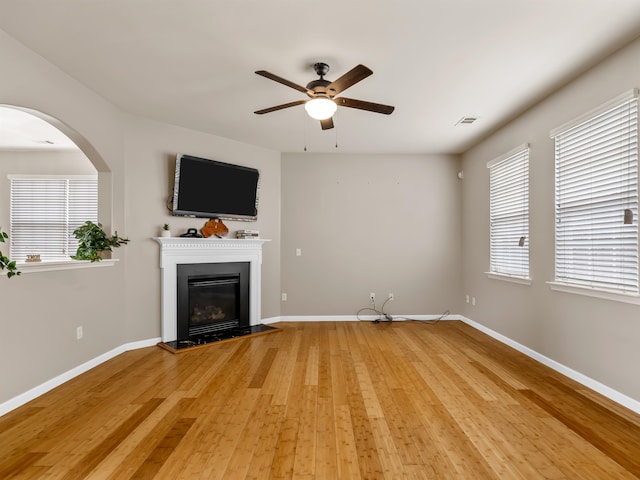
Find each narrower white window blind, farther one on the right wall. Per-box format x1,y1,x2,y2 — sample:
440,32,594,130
487,145,529,278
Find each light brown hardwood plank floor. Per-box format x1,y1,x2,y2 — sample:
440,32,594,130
0,321,640,480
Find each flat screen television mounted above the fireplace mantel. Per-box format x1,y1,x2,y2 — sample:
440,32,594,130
173,153,260,222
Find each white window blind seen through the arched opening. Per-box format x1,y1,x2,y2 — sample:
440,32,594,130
9,176,98,262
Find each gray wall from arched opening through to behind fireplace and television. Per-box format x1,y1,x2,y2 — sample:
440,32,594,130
0,30,280,404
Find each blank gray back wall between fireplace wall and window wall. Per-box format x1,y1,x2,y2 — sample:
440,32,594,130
282,153,461,316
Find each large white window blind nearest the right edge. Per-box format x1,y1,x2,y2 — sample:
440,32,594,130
552,91,638,294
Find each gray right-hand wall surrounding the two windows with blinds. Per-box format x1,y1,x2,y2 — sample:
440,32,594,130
462,35,640,400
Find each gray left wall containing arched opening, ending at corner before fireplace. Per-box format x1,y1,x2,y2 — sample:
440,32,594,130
0,31,126,402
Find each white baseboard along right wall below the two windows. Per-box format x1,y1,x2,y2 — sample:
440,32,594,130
460,317,640,414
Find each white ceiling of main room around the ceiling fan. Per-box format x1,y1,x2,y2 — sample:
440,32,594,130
0,0,640,153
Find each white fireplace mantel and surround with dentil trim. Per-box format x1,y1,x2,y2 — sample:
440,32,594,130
154,237,269,342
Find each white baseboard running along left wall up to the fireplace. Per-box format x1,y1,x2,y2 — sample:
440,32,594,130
0,338,162,416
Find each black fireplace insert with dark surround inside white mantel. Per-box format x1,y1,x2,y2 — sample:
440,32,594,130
177,262,250,340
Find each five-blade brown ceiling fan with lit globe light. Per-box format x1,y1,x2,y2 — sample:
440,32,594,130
254,63,395,130
